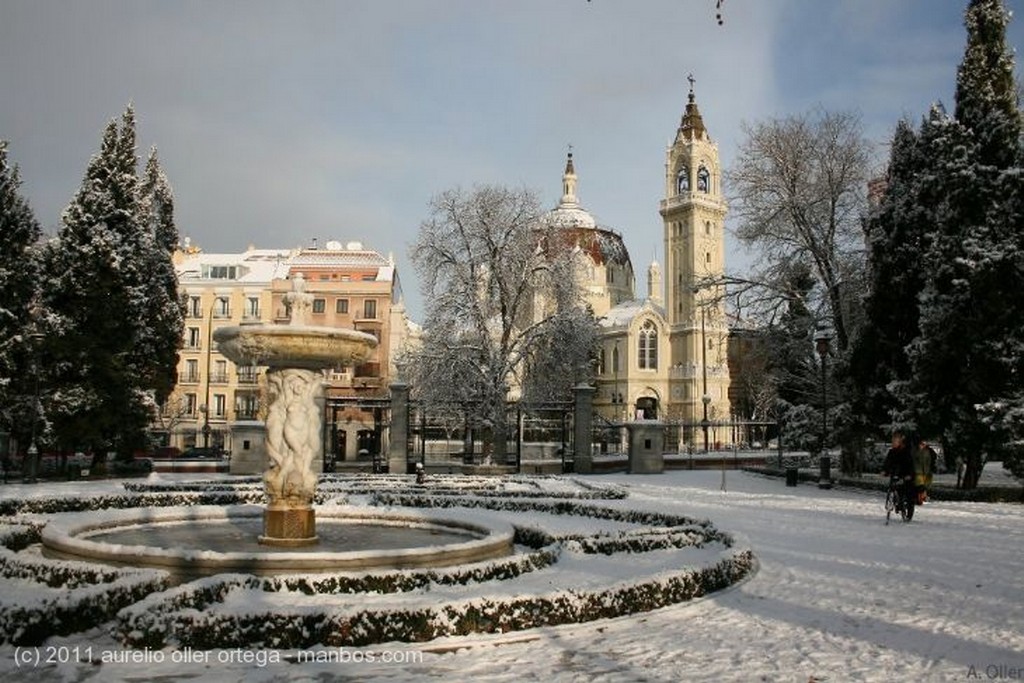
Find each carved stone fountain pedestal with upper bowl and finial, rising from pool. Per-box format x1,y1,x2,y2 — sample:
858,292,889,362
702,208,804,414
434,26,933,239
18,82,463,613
213,273,377,547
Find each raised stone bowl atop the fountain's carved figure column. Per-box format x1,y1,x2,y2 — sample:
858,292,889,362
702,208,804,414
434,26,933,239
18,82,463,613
213,325,377,370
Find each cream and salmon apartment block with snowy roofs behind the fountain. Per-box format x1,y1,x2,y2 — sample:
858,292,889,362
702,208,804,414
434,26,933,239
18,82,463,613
161,242,409,471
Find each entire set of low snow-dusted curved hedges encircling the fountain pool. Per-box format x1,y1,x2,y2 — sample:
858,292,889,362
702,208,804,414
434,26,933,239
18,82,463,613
0,475,755,649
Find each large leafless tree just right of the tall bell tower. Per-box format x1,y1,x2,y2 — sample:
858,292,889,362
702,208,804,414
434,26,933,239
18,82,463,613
727,110,869,350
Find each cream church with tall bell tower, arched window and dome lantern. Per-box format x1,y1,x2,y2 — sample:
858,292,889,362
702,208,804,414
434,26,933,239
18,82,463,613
546,84,732,447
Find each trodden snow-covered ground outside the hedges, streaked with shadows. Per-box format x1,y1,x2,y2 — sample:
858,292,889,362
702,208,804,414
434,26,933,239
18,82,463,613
0,471,1024,683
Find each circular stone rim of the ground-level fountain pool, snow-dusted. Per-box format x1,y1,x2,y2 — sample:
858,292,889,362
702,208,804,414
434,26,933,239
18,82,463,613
41,505,514,570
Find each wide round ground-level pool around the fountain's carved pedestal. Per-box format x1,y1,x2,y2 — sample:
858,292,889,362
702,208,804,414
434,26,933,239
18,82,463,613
42,505,513,579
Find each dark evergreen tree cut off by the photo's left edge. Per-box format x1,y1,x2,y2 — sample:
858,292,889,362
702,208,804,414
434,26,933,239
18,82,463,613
0,140,40,444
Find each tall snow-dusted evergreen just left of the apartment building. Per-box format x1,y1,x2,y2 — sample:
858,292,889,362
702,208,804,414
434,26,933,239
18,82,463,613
44,106,182,457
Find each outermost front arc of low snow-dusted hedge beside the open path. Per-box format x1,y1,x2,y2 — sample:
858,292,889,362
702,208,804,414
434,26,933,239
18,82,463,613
118,549,754,649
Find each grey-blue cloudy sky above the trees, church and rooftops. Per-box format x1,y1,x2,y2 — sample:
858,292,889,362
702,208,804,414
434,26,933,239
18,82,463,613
0,0,1024,317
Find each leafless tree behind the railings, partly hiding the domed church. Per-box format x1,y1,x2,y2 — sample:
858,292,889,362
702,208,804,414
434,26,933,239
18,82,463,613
403,186,593,462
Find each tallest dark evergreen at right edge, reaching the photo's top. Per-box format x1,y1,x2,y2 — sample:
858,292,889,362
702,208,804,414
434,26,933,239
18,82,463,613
907,0,1024,486
